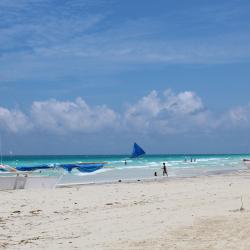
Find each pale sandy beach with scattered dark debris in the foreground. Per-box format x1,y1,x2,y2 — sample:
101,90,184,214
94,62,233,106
0,171,250,250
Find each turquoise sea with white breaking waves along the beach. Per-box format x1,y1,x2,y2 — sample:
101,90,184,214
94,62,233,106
2,154,250,183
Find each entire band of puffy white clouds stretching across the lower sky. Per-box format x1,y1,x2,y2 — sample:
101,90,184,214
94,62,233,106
0,90,250,134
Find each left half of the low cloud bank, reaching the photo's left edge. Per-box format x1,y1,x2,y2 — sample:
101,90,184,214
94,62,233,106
0,98,118,133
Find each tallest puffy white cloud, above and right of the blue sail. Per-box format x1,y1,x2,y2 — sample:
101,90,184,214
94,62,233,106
125,90,209,133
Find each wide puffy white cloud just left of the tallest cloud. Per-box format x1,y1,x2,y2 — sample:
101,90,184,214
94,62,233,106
31,98,117,133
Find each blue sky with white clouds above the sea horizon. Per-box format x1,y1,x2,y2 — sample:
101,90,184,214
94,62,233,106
0,0,250,154
